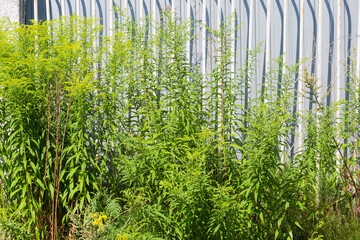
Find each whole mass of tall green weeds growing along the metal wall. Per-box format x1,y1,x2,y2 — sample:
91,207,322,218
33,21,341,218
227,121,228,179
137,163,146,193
0,12,360,239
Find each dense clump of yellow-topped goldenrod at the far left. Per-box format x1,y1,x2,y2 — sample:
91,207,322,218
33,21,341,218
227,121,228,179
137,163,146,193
0,17,100,239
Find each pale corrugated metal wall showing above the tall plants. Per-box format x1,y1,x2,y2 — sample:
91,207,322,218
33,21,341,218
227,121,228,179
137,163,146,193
26,0,360,148
